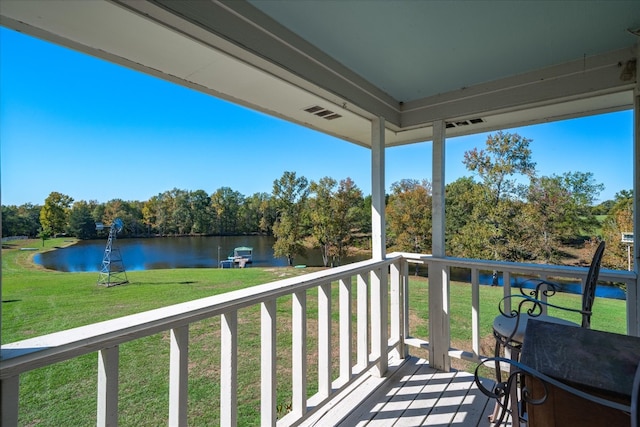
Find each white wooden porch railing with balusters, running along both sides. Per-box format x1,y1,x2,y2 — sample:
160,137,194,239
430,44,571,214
0,254,638,426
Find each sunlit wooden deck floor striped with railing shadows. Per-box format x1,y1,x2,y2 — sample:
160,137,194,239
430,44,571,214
301,358,493,427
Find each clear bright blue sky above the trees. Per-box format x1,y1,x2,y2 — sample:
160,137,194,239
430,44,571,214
0,28,633,205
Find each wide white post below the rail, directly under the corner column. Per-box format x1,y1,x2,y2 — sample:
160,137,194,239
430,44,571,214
371,267,389,377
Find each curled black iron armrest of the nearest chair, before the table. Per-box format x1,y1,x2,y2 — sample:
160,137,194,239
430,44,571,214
474,357,640,427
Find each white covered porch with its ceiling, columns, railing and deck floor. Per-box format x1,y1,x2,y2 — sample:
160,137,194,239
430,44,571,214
0,0,640,426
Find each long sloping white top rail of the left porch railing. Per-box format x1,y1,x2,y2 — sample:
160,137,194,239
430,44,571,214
0,255,400,379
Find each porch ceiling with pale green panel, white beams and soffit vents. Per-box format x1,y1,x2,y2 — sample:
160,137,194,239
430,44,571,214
0,0,640,146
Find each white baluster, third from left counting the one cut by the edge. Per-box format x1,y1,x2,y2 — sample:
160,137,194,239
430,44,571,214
169,325,189,427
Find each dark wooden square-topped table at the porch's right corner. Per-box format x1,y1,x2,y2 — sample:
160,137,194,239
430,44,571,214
520,320,640,427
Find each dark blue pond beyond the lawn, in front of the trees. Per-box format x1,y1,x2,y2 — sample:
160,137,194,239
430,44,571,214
34,236,626,299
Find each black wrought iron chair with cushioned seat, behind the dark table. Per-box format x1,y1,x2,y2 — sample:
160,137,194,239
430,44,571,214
490,241,605,427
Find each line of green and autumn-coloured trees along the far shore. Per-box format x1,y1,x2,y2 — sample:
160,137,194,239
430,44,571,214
2,132,633,269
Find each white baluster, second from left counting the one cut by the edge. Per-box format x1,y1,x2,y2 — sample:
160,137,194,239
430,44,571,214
96,346,119,427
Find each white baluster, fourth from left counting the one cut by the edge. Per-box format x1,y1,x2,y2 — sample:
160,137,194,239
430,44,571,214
220,310,238,427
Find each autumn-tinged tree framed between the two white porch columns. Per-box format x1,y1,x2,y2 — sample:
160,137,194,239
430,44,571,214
386,179,432,253
